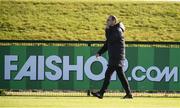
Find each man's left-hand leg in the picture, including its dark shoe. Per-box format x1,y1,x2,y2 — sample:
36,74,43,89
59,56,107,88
91,66,115,99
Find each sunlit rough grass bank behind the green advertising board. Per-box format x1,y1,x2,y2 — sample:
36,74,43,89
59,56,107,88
0,0,180,41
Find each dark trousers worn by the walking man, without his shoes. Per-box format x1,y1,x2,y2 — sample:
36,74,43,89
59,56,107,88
100,66,131,94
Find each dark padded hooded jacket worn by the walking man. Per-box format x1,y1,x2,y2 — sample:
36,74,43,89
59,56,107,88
98,23,125,66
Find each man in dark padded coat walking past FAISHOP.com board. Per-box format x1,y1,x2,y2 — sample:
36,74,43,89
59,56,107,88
91,15,133,99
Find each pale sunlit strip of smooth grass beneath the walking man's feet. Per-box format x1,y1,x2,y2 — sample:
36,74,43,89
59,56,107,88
0,96,180,108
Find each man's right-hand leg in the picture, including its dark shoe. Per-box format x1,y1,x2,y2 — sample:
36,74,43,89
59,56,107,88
116,66,132,98
